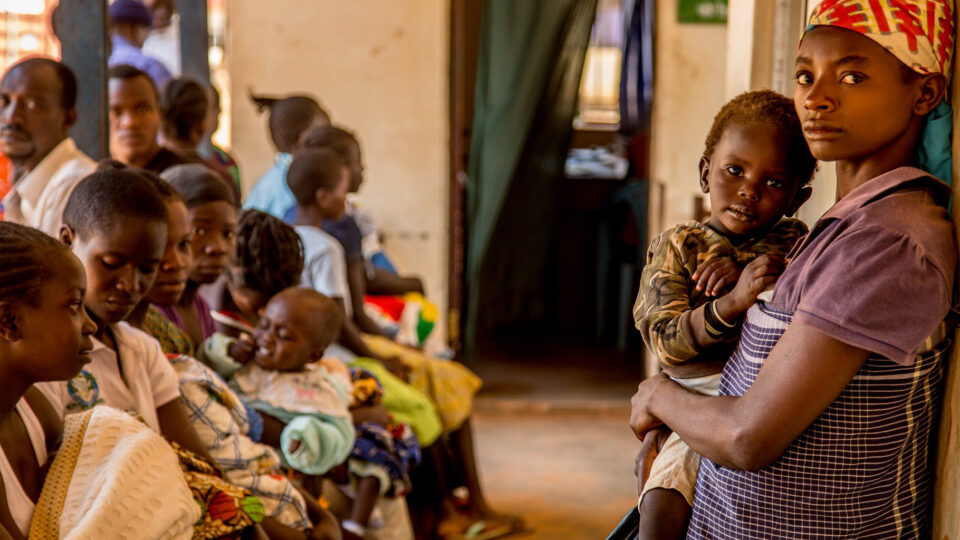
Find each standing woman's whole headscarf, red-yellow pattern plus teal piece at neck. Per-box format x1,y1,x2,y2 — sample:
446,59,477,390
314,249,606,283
804,0,954,184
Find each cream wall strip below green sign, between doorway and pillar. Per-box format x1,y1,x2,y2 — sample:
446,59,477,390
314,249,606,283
650,0,727,231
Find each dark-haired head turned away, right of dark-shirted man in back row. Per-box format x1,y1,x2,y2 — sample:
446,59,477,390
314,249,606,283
160,78,208,147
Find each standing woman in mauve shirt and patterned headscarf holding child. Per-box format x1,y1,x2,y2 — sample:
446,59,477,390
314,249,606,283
631,0,957,538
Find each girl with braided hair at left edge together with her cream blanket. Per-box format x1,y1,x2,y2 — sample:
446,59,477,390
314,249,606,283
0,223,200,539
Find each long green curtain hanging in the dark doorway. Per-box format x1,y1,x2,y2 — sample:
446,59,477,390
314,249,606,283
465,0,597,348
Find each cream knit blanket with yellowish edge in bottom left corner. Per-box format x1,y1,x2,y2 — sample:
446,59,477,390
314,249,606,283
30,405,200,540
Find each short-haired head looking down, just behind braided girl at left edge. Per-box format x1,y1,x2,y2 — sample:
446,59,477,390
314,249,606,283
60,169,167,323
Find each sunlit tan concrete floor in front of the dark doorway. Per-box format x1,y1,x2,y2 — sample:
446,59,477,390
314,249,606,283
474,412,639,540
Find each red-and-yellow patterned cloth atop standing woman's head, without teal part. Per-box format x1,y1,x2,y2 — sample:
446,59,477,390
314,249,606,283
807,0,954,79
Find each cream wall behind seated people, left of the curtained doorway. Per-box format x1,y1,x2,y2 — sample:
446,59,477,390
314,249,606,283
226,0,450,338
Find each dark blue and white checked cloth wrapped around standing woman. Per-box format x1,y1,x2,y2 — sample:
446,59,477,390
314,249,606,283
687,302,949,539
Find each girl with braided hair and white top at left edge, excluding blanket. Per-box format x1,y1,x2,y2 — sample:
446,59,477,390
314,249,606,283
0,223,96,539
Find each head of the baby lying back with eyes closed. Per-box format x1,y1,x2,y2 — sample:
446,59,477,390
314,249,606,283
253,287,343,371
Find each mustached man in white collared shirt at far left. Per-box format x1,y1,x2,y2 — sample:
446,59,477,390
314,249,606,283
0,58,96,236
